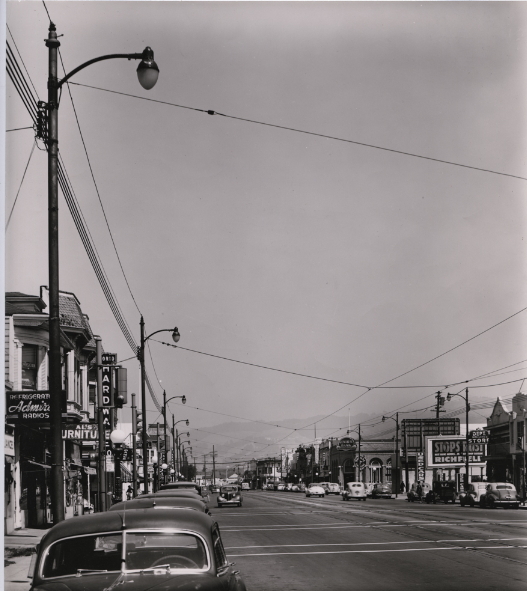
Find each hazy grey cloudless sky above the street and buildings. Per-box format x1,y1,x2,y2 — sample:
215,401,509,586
5,0,527,468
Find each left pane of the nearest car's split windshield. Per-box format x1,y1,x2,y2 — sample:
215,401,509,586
42,533,122,579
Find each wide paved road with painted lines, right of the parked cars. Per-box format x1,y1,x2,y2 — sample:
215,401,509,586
211,491,527,591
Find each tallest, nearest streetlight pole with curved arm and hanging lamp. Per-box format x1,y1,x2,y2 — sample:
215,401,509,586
45,23,159,524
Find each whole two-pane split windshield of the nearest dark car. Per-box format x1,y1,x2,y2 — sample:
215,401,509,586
42,531,209,579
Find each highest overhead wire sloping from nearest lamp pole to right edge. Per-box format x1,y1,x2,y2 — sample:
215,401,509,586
71,82,527,181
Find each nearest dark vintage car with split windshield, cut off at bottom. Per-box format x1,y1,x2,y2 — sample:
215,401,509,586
29,509,249,591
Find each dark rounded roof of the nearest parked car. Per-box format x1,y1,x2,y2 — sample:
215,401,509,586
38,509,215,546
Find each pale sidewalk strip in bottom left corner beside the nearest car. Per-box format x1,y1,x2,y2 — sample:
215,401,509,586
4,529,47,591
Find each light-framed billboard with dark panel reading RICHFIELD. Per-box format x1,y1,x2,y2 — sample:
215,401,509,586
426,437,487,468
